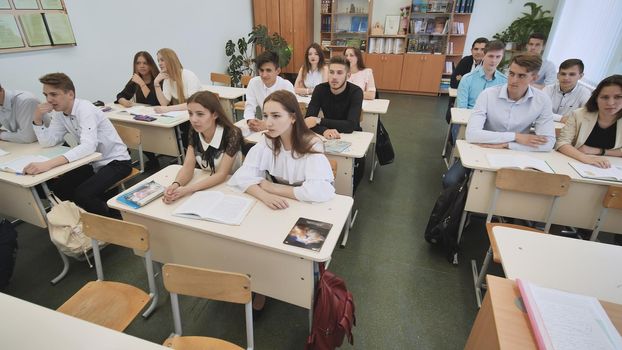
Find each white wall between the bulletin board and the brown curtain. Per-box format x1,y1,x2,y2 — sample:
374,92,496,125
0,0,253,101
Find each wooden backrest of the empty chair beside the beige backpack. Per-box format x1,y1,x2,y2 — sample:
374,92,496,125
80,212,149,252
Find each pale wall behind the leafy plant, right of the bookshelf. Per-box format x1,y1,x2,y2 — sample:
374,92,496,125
463,0,557,56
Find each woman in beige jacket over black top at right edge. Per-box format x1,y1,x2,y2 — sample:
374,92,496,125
555,74,622,168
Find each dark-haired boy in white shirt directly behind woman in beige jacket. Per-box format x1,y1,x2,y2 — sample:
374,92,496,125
542,58,592,123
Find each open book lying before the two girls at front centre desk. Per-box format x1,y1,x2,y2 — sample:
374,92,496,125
173,191,255,225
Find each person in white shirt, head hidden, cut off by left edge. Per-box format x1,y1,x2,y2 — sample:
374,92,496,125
0,85,39,143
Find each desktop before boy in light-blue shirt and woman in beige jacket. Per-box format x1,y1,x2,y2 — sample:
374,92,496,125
456,140,622,186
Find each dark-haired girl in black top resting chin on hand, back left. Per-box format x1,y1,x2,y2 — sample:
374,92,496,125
116,51,160,107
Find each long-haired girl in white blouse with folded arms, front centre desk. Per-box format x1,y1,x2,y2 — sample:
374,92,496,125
228,90,335,209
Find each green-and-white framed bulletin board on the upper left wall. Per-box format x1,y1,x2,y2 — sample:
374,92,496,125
0,0,76,54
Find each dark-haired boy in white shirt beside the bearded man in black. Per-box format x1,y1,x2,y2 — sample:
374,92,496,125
244,51,294,131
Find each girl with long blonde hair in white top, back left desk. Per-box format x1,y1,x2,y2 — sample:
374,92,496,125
154,48,201,113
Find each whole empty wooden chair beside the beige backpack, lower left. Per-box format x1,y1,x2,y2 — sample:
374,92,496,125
57,213,158,332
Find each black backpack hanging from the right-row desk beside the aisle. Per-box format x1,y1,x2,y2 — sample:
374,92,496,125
424,176,469,264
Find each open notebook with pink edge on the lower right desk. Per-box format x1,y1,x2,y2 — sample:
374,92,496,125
516,278,622,350
